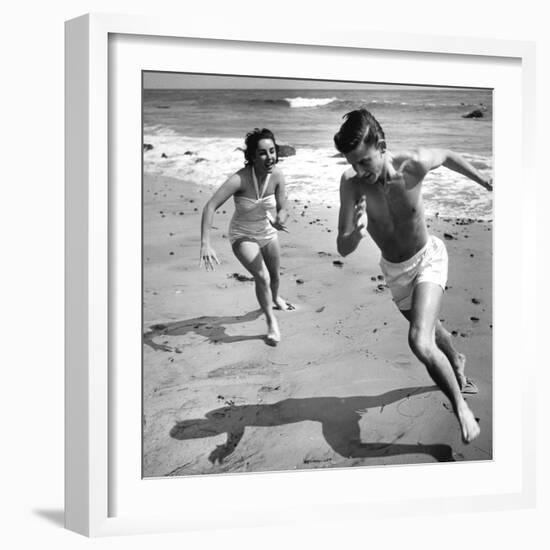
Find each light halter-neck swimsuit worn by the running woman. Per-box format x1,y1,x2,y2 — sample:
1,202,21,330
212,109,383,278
229,167,277,248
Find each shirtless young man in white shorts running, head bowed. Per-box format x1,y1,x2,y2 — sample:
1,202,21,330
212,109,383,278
334,109,493,443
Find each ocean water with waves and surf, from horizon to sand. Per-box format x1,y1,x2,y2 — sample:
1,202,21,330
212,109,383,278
143,88,493,219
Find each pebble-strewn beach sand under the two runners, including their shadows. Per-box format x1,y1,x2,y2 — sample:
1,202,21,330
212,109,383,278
143,174,493,477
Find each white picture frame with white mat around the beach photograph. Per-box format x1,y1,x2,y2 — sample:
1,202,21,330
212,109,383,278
65,11,536,536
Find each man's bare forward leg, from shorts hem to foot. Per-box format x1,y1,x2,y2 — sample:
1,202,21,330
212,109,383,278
409,282,480,443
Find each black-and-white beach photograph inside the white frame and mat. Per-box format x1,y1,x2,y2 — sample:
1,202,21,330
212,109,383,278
142,72,493,478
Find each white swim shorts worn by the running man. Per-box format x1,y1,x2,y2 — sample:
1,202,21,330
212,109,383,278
380,235,449,311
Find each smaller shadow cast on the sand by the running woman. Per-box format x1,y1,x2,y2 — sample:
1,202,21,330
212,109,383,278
143,309,265,351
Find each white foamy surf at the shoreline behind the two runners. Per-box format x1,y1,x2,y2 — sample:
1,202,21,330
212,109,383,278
143,131,493,219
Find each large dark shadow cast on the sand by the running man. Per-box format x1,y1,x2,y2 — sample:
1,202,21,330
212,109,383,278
170,386,454,463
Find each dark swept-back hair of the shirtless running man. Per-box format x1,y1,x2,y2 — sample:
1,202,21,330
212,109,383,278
334,109,386,154
